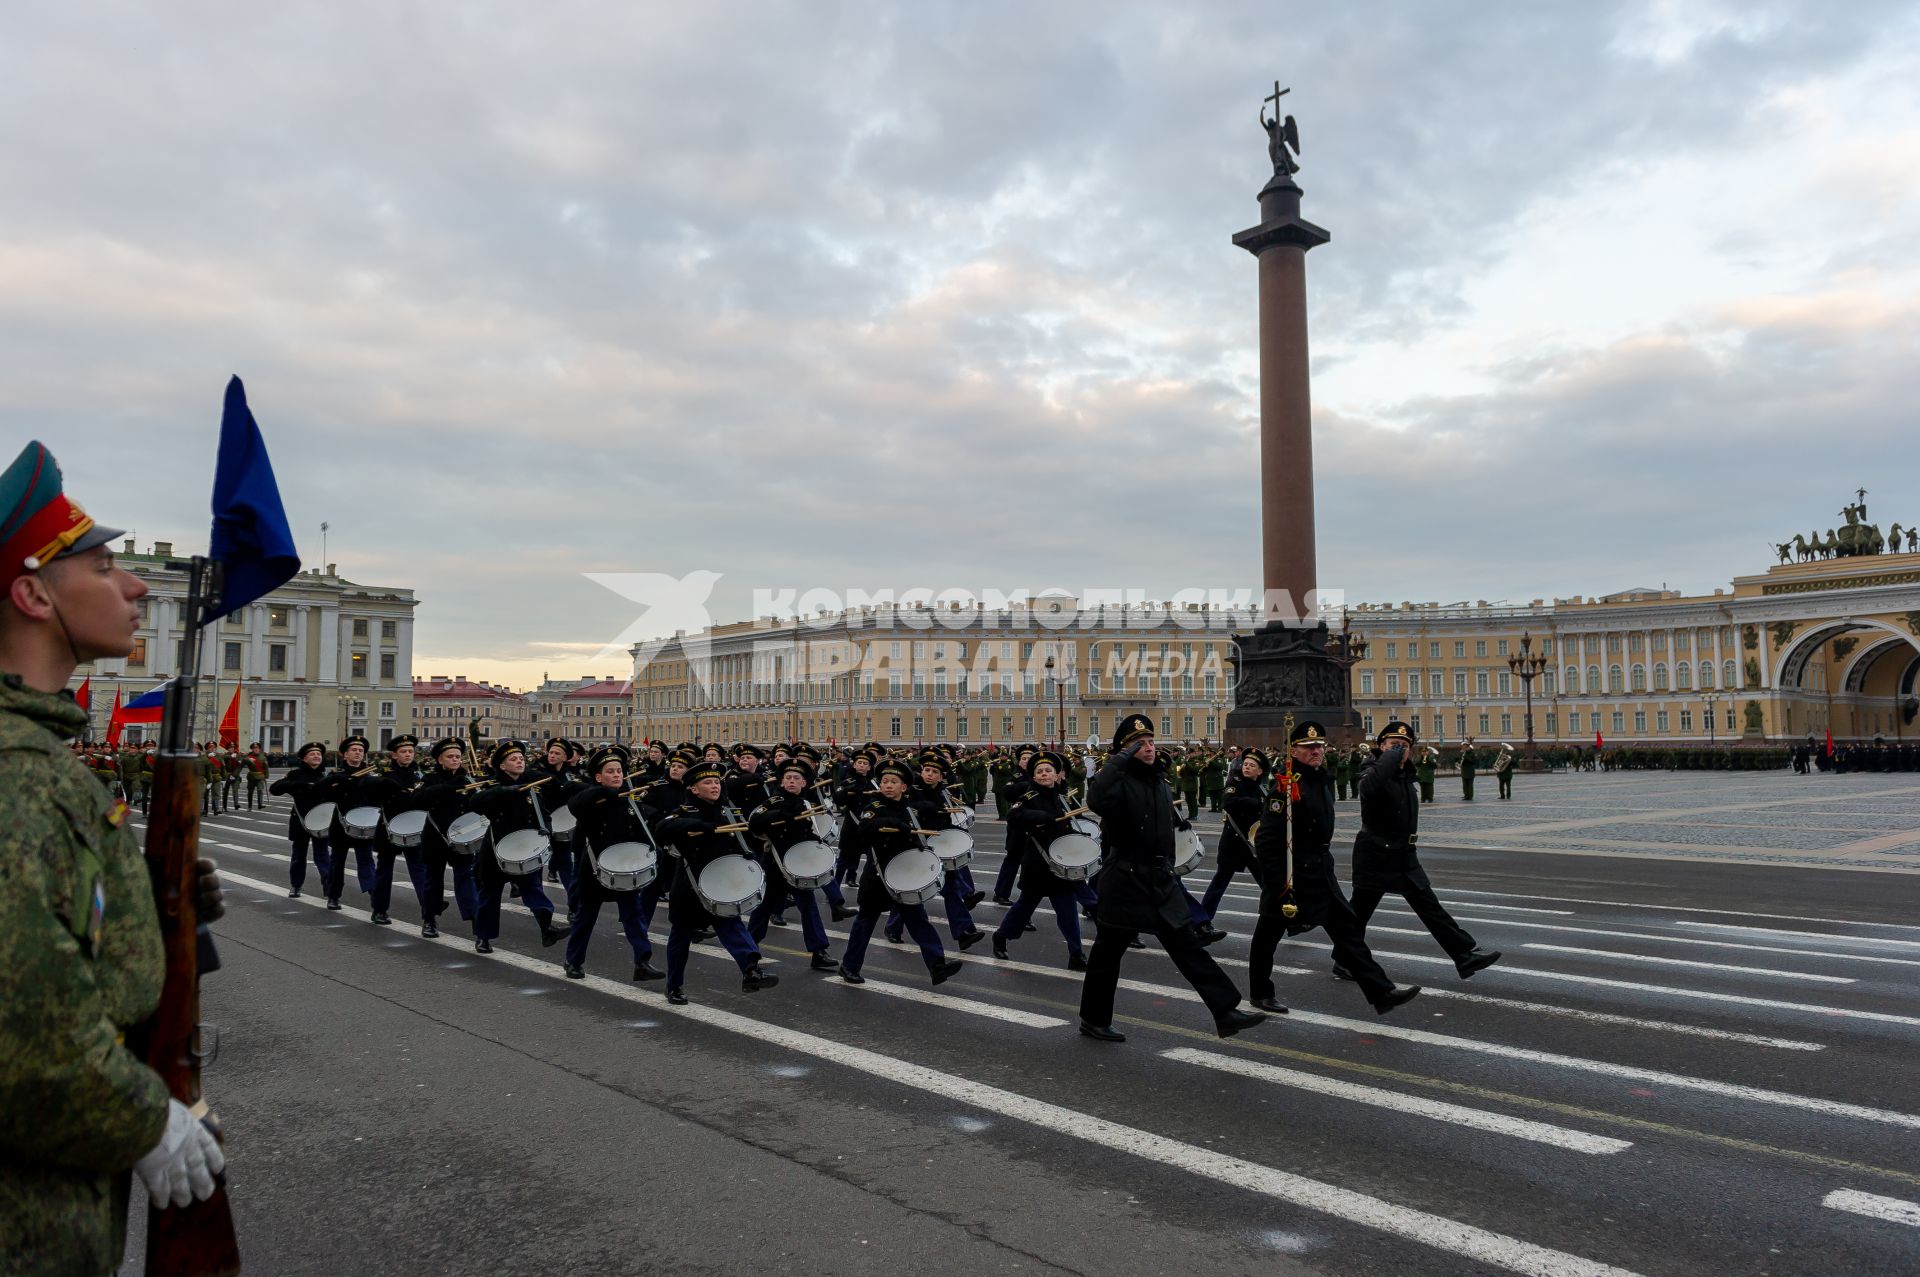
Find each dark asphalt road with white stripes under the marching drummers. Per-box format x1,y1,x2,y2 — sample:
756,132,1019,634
120,778,1920,1277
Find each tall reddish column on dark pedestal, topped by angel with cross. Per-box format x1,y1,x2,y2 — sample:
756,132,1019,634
1225,83,1365,747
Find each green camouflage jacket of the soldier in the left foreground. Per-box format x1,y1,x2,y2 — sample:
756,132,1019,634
0,676,167,1275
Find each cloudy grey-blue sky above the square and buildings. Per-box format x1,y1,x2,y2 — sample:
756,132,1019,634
0,0,1920,686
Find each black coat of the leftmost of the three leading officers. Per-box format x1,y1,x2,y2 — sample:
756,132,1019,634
1087,755,1192,931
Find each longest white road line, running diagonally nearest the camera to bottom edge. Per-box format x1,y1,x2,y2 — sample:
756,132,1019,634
217,876,1636,1277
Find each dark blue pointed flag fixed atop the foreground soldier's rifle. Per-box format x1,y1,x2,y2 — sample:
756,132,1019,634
207,376,300,620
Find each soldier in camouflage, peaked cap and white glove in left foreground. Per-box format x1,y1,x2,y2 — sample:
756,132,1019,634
0,444,225,1277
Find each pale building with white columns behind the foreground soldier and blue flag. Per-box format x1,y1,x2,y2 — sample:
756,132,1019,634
71,540,419,753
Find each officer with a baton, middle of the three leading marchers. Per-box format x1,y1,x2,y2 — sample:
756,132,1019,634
1246,720,1421,1016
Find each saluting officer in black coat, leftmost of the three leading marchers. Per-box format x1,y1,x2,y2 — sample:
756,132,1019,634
1081,714,1265,1043
